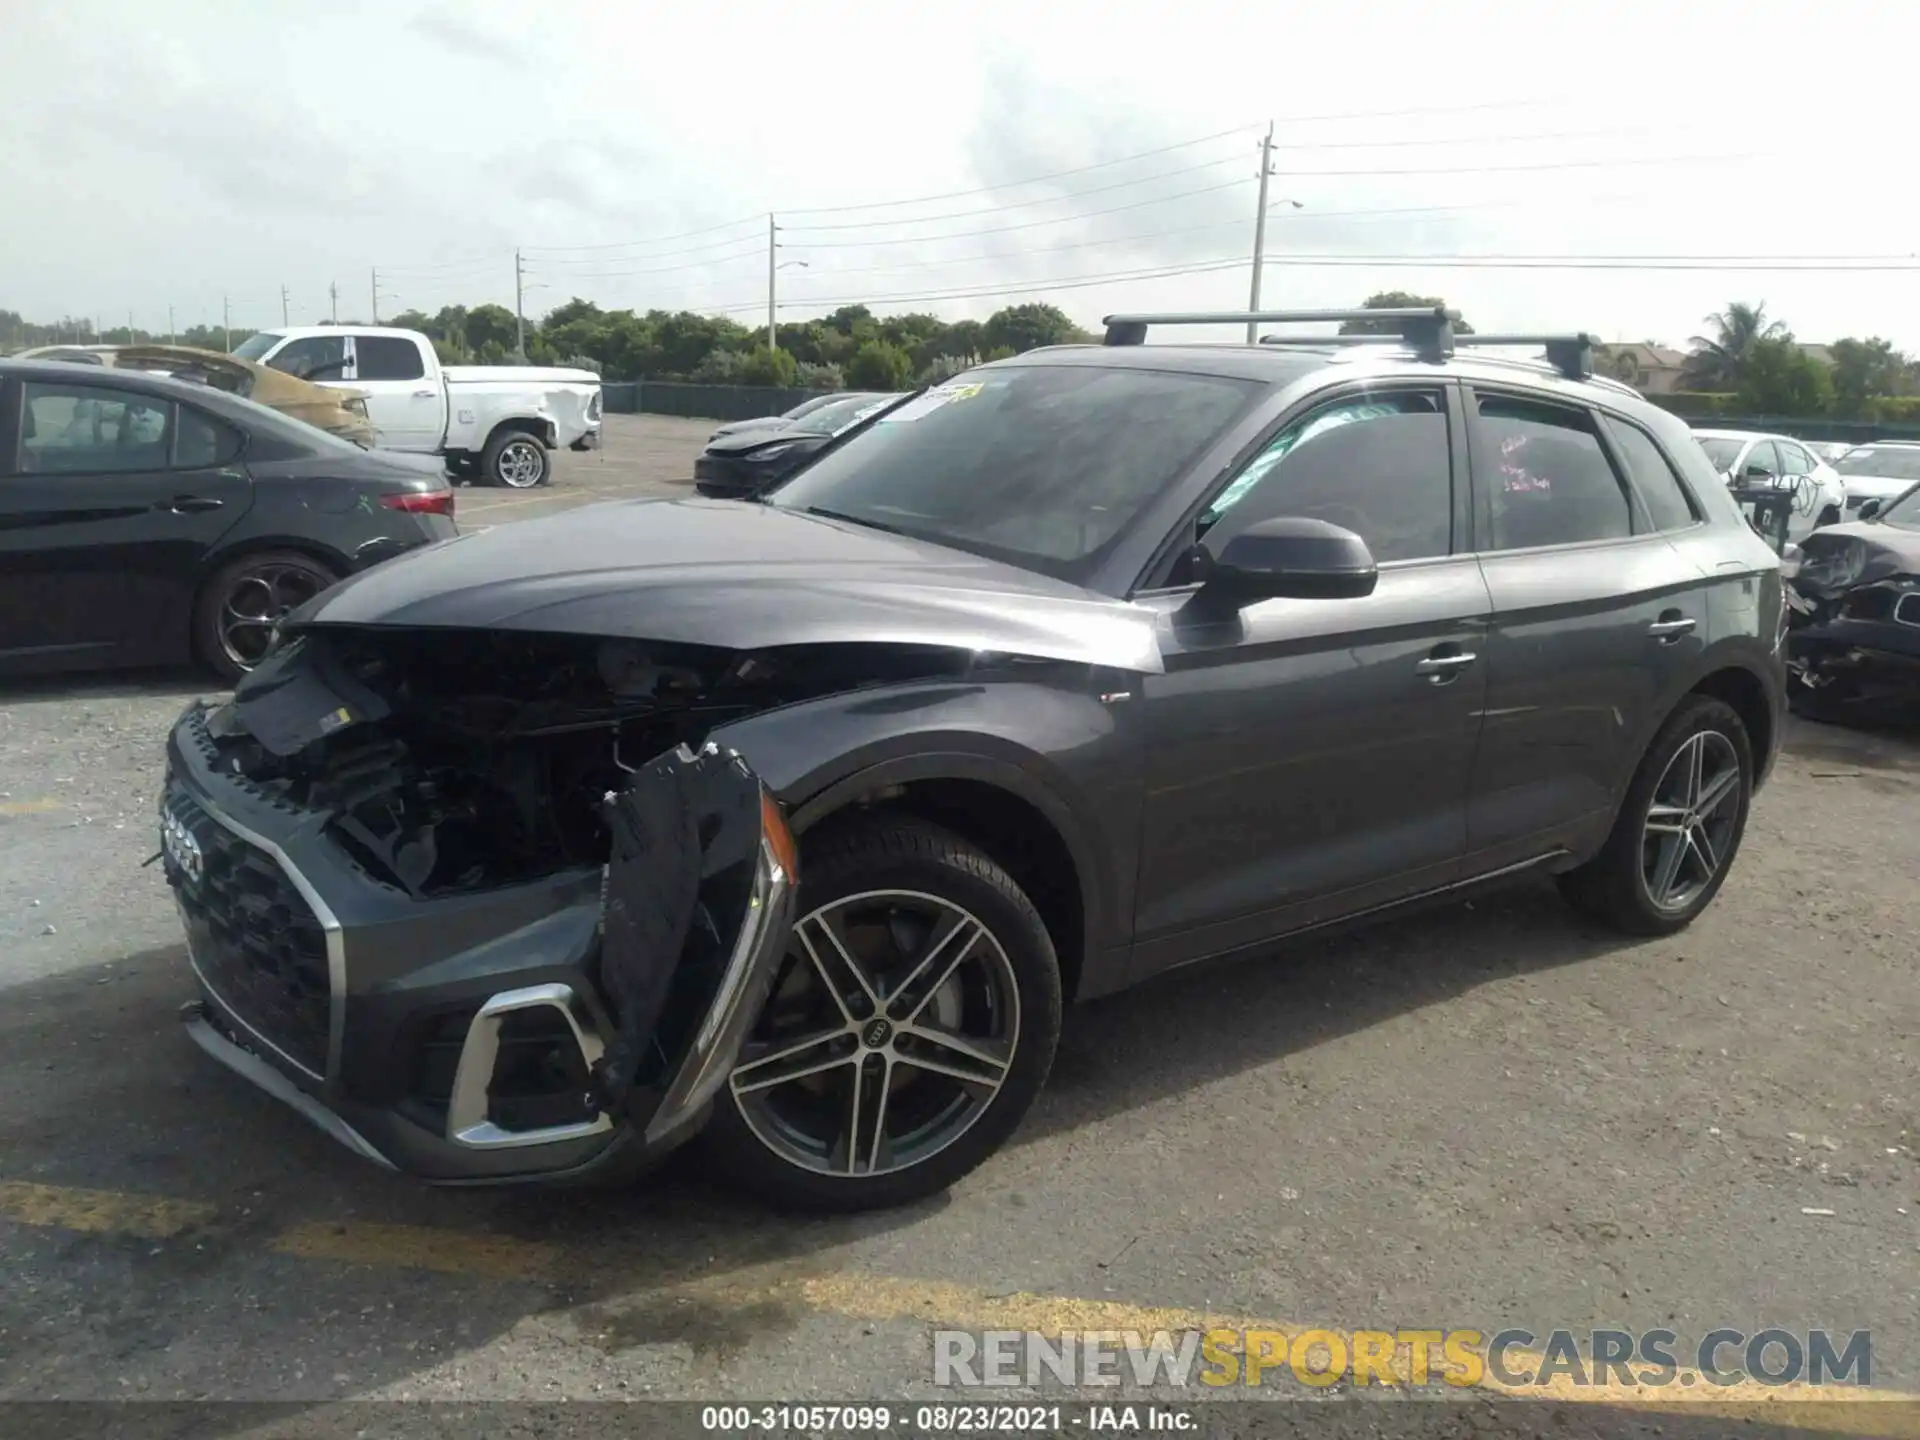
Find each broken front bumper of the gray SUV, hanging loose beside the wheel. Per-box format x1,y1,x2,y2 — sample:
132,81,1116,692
159,705,797,1183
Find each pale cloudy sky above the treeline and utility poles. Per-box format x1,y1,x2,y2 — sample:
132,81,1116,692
0,0,1920,349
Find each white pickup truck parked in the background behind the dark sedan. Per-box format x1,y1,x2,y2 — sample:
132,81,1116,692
234,324,601,490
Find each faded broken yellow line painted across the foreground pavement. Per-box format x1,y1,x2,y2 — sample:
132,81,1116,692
0,1181,1920,1436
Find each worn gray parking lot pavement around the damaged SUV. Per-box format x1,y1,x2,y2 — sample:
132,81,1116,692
0,417,1920,1434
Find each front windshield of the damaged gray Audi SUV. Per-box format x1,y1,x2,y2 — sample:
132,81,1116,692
770,365,1261,580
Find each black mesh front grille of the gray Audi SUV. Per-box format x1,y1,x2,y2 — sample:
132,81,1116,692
167,791,332,1075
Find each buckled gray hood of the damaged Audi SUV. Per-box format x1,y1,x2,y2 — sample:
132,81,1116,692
286,499,1162,672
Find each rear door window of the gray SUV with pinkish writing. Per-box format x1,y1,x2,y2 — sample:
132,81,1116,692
1475,396,1634,549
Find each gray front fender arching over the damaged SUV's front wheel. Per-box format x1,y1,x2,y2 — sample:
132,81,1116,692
712,668,1140,971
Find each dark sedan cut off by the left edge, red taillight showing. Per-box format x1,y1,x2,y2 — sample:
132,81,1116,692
0,361,457,680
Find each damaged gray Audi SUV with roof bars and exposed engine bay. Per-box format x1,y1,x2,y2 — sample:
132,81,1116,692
161,311,1784,1210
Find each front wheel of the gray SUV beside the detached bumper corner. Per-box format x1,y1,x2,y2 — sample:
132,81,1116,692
703,816,1060,1212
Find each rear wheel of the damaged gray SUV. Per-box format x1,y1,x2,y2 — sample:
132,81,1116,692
1559,695,1753,935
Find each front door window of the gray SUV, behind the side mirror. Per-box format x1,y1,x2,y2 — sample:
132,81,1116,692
1198,390,1453,564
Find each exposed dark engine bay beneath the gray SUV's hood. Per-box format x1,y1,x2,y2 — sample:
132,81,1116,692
207,626,972,899
